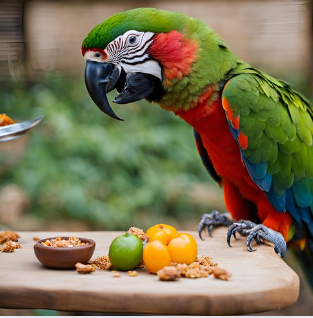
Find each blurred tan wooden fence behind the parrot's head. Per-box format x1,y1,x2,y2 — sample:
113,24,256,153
0,0,313,82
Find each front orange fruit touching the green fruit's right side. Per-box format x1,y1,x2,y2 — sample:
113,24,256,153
143,240,171,274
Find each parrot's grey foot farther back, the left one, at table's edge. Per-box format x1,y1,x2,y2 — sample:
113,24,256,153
198,210,233,240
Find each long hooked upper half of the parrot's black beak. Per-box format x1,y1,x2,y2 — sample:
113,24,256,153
85,61,124,120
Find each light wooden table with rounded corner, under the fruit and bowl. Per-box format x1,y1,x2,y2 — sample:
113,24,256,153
0,228,299,315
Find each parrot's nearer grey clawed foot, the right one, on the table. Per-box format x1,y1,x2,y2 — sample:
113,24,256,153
227,220,287,258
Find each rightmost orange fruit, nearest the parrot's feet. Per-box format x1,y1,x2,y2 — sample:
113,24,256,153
167,233,198,265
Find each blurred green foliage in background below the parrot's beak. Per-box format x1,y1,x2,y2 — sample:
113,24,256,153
0,76,217,230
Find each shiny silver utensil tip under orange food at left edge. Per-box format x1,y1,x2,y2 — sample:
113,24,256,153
0,115,44,142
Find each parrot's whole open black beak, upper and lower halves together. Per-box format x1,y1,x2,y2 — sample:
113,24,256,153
85,60,162,120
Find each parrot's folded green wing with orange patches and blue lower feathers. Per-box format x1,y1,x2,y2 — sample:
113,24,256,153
222,63,313,234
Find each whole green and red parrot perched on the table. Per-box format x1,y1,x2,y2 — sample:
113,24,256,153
81,8,313,276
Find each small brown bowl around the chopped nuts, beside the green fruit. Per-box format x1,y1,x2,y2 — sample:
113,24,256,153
34,236,96,269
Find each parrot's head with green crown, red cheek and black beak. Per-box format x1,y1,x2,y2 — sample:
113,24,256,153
82,8,235,120
